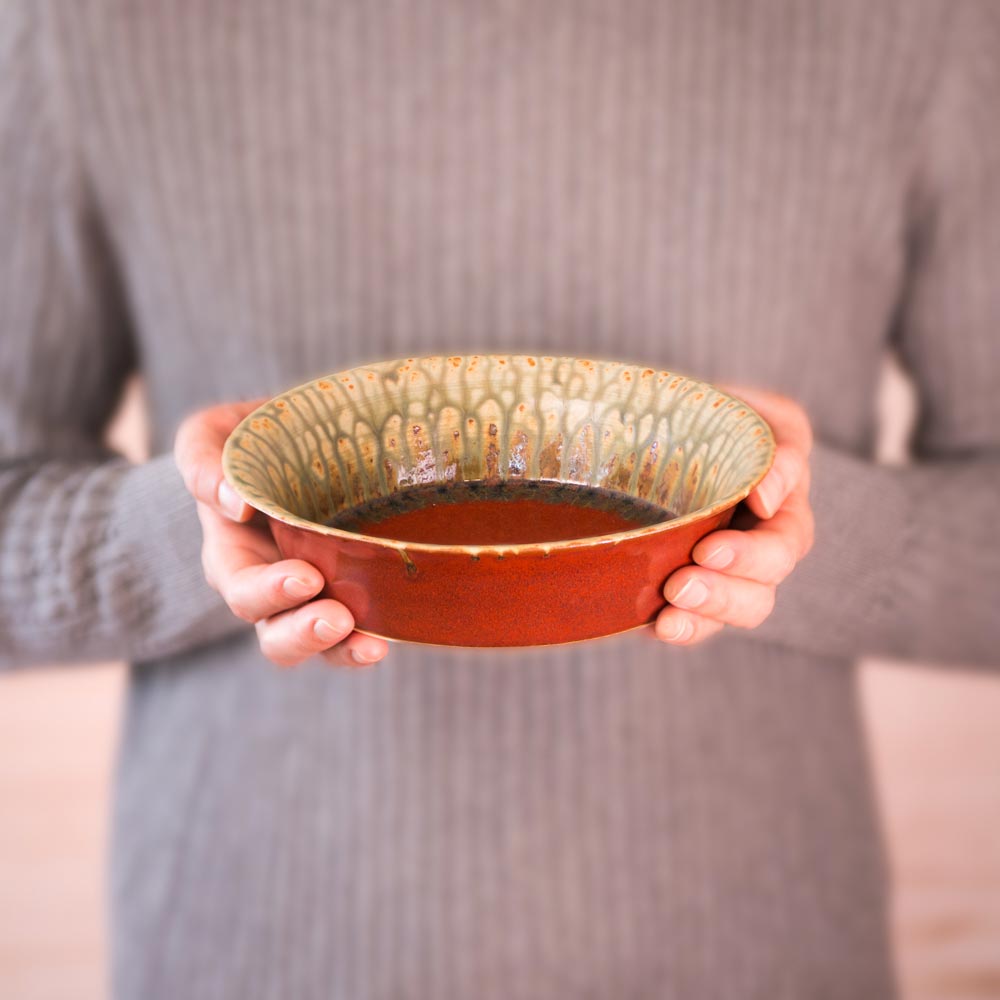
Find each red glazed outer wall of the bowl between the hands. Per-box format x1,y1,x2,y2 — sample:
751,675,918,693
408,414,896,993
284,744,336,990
271,505,735,646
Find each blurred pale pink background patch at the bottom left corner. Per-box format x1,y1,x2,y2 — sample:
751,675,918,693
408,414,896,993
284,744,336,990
0,667,124,1000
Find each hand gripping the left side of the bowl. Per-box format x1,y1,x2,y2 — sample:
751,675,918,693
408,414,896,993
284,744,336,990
174,400,388,667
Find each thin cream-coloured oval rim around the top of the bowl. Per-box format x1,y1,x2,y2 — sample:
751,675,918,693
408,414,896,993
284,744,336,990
222,353,777,556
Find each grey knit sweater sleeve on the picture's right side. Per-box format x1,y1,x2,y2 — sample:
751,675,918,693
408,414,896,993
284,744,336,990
757,0,1000,666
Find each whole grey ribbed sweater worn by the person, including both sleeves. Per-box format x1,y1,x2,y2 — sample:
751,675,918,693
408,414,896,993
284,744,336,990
0,0,1000,1000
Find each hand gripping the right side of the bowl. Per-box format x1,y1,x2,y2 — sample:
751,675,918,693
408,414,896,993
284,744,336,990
654,388,813,646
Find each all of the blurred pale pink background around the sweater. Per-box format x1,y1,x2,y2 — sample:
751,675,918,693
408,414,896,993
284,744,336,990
0,366,1000,1000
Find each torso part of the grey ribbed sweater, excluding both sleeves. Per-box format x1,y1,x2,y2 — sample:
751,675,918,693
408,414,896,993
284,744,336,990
9,0,976,1000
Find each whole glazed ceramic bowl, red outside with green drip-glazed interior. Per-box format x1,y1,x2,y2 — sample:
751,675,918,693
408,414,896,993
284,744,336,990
223,355,774,646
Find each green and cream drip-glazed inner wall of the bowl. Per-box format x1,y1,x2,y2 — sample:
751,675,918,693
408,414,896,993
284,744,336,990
224,355,774,544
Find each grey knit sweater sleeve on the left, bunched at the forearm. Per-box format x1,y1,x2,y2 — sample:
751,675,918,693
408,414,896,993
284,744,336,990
0,2,240,666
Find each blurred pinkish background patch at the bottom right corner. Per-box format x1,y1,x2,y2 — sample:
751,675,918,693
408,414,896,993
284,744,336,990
864,665,1000,1000
